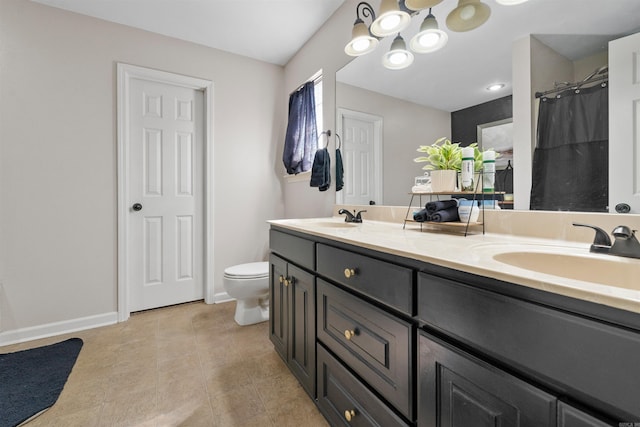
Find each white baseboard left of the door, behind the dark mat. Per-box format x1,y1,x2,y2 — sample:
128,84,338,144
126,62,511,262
0,311,118,346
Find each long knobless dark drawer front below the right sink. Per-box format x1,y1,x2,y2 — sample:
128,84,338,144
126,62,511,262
418,273,640,419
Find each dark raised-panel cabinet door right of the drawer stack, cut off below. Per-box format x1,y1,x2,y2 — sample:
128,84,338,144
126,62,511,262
418,331,556,427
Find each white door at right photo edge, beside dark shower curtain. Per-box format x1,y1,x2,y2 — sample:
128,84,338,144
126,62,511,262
609,33,640,214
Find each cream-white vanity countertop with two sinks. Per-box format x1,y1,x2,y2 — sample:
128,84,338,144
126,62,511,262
269,217,640,313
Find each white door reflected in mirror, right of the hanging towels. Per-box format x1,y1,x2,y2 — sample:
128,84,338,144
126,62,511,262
336,110,382,205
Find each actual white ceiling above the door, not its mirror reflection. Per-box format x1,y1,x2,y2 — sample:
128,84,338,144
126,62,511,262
33,0,350,65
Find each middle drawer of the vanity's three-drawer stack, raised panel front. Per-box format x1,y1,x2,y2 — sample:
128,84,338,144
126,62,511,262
316,279,414,420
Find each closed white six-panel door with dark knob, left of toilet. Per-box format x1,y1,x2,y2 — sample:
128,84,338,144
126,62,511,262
127,79,204,311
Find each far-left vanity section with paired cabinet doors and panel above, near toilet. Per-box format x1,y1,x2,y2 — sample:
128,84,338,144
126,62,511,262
269,231,316,398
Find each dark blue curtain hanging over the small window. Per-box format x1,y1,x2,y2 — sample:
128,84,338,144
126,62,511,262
282,82,318,175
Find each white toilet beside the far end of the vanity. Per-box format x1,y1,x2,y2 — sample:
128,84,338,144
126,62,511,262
224,261,269,326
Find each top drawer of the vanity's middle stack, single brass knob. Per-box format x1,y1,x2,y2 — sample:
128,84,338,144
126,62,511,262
317,244,413,316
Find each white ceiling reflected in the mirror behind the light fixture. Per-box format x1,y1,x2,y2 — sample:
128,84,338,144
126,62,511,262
337,0,640,111
